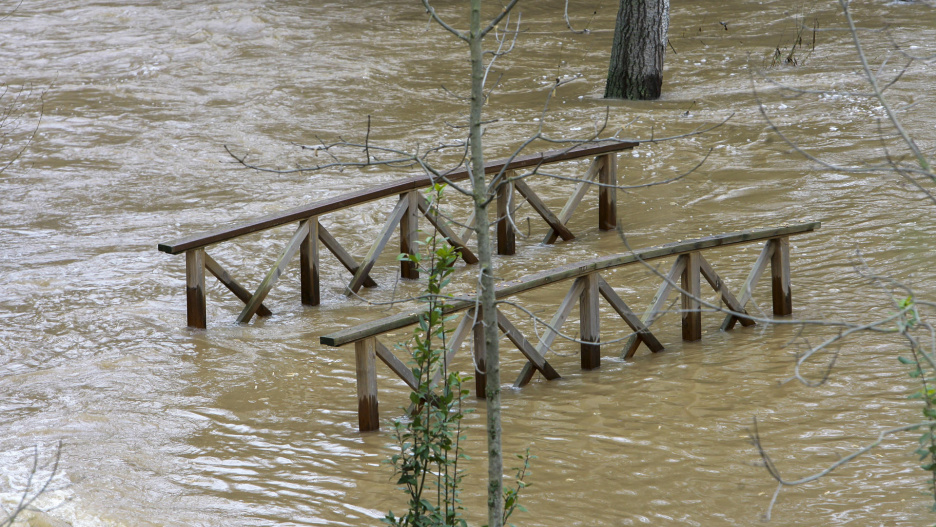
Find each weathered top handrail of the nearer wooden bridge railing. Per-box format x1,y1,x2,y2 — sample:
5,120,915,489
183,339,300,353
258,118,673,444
319,221,821,347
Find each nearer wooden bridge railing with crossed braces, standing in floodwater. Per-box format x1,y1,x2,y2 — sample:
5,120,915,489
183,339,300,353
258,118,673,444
321,222,820,431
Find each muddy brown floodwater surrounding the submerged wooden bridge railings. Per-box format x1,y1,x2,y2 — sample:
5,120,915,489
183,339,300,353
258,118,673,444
0,0,936,526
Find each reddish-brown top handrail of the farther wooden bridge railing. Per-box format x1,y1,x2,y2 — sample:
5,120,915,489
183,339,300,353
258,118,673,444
158,141,638,254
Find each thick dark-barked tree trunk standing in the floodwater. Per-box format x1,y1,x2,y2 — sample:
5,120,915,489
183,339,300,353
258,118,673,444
605,0,669,100
